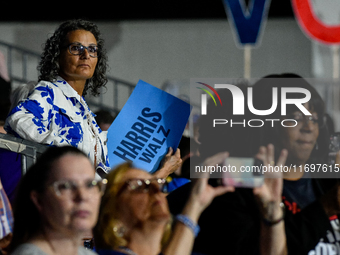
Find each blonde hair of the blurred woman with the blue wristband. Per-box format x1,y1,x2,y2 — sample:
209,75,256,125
94,162,172,250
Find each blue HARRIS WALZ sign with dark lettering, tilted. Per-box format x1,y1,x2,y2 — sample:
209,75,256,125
107,80,191,173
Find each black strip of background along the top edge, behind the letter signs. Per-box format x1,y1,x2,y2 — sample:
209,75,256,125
0,0,293,22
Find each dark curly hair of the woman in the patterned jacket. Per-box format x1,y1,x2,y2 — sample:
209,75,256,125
38,19,107,96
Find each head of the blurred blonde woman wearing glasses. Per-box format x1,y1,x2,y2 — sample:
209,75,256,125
94,163,170,252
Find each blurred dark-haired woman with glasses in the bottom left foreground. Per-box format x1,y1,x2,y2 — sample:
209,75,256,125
10,146,106,255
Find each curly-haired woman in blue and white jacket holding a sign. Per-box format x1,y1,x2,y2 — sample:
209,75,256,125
5,20,180,176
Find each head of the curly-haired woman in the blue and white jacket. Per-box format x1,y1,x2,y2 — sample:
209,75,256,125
38,17,107,96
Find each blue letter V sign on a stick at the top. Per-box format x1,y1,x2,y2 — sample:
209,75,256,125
223,0,270,45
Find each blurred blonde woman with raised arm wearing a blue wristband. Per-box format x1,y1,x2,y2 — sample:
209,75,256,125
94,159,234,255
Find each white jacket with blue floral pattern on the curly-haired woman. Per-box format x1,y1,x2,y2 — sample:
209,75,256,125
5,77,109,171
